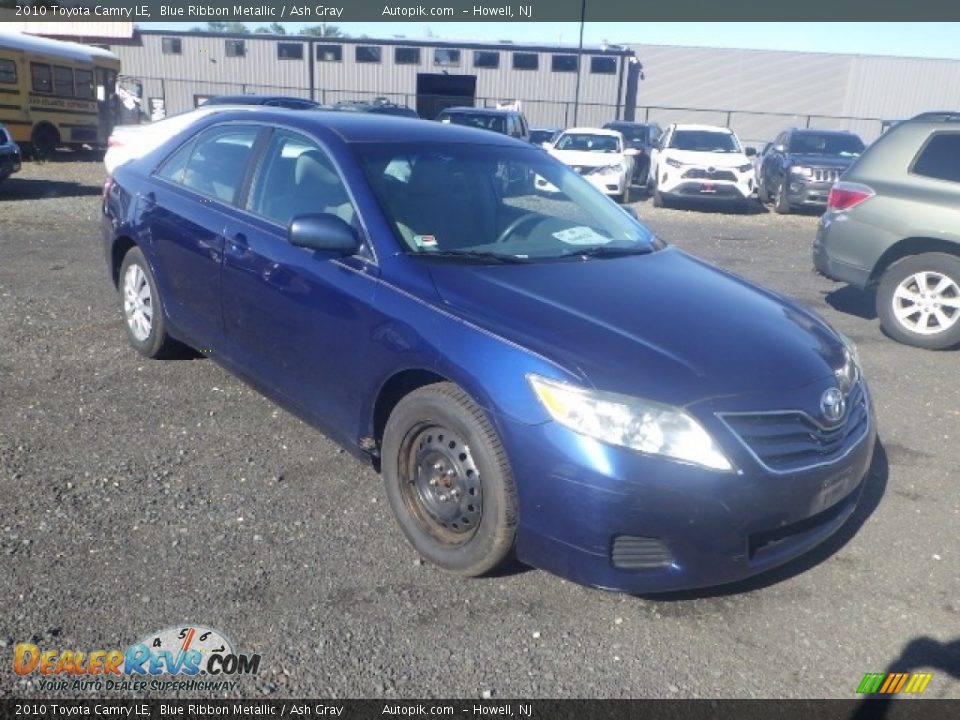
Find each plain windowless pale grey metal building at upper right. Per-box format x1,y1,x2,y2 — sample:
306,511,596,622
631,45,960,143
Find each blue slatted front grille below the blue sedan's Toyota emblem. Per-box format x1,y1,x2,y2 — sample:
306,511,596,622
721,383,870,472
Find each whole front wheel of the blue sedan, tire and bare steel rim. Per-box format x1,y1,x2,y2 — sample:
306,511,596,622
381,382,517,577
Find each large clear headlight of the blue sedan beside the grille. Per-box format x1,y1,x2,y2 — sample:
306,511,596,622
528,375,733,470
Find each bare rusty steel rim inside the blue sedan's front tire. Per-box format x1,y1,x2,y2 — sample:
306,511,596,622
400,425,483,546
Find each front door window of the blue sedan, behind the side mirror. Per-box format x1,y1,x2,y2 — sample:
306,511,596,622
247,130,359,229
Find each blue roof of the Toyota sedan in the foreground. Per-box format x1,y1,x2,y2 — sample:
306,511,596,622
182,107,530,148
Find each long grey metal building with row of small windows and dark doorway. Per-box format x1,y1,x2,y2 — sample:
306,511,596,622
99,30,637,127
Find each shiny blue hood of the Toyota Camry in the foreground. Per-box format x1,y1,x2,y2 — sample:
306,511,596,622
430,248,843,405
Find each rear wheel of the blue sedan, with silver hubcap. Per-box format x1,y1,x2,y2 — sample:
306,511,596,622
119,247,179,358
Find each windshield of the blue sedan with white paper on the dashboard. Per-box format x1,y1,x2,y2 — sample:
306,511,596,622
354,143,656,262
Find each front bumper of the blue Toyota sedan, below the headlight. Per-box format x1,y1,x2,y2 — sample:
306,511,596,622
503,382,876,593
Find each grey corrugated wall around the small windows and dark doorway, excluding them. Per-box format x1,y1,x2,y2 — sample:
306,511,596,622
111,31,625,127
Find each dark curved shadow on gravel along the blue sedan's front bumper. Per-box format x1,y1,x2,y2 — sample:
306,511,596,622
634,438,890,602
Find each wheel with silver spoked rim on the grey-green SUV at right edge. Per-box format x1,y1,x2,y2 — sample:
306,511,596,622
877,252,960,350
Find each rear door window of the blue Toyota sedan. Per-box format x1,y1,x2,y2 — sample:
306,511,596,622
181,126,258,203
